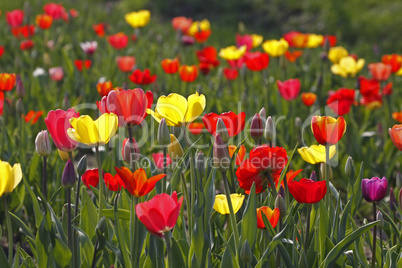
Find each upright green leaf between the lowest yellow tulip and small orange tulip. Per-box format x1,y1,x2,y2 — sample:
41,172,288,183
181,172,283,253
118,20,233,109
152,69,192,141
237,183,258,251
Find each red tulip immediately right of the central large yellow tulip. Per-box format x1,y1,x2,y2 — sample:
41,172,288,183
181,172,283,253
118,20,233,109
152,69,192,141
202,111,246,137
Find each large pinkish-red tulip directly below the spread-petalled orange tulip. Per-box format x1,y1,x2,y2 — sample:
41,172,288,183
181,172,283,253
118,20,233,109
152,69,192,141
135,191,183,237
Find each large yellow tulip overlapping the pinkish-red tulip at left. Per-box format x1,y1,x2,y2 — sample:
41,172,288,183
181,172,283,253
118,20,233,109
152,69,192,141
67,113,118,146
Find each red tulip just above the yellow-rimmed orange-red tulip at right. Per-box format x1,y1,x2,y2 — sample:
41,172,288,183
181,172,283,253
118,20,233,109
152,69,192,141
327,88,355,115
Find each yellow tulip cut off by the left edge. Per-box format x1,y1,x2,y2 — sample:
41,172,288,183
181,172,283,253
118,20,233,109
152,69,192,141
0,161,22,196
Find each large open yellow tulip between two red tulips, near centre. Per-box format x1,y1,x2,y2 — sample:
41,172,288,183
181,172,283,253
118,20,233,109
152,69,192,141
147,92,206,127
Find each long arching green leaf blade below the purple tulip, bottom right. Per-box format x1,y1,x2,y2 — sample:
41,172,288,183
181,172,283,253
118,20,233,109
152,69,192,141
320,221,380,267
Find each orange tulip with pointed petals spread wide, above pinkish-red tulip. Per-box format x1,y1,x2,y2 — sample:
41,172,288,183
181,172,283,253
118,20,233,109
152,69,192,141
115,167,166,197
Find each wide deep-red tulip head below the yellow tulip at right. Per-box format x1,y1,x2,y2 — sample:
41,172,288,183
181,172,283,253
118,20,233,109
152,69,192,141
288,178,327,204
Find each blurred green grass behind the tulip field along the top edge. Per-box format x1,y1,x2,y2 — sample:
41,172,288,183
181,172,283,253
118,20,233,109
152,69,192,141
0,0,402,60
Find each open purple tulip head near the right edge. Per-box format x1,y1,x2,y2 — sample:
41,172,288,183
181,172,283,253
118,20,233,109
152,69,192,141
362,177,388,202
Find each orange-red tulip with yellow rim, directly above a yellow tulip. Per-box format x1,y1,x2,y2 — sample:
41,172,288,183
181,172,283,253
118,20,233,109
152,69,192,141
311,116,346,145
